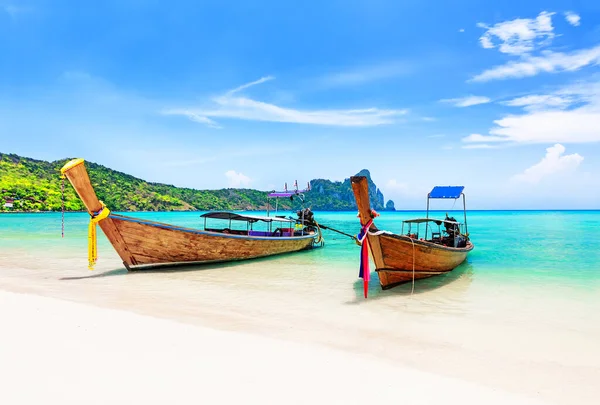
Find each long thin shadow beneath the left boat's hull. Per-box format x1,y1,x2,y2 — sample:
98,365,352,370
59,249,311,281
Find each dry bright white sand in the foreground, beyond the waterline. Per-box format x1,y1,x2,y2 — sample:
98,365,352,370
0,292,543,405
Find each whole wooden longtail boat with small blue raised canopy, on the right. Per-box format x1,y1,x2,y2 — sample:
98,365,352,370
350,176,473,290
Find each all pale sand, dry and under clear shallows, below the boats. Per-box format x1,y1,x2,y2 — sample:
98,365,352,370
0,240,600,405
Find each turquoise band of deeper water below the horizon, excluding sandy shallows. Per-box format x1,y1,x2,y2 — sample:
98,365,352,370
0,211,600,289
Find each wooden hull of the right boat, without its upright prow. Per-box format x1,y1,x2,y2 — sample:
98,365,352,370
368,234,473,290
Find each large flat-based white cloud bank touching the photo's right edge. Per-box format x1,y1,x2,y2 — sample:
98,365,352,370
463,82,600,143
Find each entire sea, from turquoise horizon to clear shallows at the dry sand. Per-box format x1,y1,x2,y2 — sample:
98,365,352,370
0,210,600,404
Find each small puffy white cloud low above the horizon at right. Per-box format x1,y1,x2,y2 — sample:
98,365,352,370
513,143,583,183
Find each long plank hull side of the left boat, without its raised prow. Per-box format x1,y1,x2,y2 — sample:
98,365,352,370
109,214,316,269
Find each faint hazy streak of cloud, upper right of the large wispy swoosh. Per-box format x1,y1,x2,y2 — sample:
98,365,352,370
317,61,413,87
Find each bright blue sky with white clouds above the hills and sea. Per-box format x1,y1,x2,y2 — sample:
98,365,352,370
0,0,600,209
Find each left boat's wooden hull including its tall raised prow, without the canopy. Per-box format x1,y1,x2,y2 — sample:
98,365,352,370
61,159,322,270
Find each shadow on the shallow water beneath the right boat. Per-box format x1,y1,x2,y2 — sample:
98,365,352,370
347,262,473,304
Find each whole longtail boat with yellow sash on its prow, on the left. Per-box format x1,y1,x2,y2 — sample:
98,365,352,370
61,159,322,270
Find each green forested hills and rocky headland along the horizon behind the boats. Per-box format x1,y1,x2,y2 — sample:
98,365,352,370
0,153,395,212
